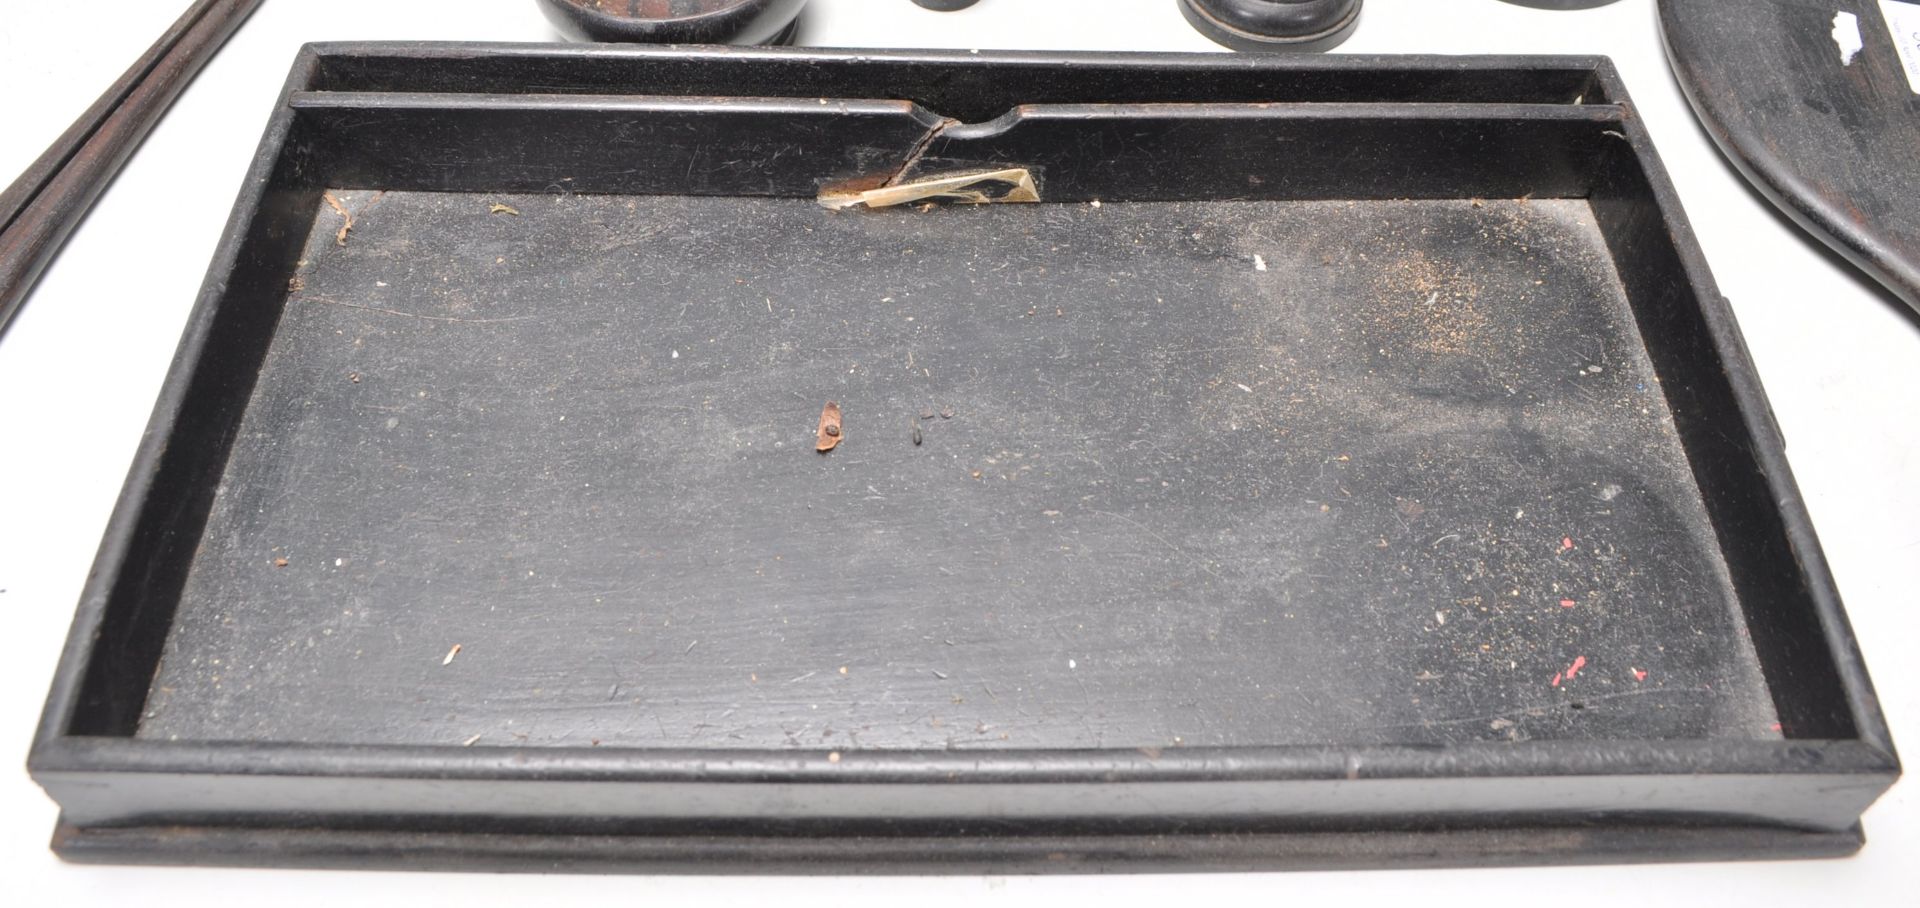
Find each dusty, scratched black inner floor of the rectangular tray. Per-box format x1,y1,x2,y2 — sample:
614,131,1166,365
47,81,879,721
138,192,1776,749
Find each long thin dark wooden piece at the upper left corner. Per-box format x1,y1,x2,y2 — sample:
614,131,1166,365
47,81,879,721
0,0,261,330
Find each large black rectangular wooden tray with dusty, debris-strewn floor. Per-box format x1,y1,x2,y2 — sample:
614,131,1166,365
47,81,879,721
31,44,1899,872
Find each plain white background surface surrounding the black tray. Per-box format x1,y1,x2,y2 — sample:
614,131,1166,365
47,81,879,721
0,0,1920,908
